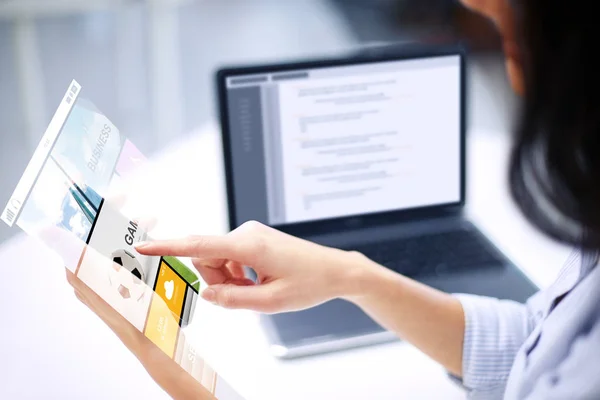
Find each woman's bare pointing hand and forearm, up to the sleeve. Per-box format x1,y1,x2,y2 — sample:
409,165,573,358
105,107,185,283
137,223,465,376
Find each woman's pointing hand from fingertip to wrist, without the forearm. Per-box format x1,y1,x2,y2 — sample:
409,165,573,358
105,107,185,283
136,222,375,313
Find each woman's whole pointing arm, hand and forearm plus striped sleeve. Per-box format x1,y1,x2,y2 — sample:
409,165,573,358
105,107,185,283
137,222,544,391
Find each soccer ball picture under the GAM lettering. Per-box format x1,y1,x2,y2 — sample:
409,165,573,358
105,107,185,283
108,249,146,301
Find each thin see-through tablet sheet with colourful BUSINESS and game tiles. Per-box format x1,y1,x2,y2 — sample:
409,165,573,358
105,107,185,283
0,81,248,399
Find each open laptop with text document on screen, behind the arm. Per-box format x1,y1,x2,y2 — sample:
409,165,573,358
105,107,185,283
217,46,537,358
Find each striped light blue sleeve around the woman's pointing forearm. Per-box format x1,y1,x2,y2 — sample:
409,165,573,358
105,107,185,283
455,294,539,399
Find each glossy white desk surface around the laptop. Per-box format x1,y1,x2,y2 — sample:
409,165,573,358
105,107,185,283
0,126,569,400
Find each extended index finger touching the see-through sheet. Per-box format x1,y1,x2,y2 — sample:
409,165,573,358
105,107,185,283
135,236,243,259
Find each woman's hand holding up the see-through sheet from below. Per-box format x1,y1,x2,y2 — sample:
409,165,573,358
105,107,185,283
67,270,216,400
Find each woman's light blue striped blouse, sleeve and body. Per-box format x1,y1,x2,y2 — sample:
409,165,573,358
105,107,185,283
455,252,600,400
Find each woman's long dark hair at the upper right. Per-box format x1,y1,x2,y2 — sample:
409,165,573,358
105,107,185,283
509,0,600,250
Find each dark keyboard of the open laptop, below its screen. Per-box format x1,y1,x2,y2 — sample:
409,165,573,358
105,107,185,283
348,229,504,277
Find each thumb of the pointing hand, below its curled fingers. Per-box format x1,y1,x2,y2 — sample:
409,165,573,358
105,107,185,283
202,284,281,313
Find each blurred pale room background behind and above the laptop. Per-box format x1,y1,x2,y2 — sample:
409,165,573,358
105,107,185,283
0,0,516,243
